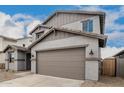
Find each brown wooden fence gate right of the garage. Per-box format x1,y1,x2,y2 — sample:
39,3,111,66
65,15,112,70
102,58,116,76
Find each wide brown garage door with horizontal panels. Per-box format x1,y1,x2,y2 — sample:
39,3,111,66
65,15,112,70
37,48,85,80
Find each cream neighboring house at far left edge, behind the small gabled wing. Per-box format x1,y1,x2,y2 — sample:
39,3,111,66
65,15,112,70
0,35,17,63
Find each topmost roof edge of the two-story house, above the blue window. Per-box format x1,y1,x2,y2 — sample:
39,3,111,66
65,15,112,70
42,10,105,34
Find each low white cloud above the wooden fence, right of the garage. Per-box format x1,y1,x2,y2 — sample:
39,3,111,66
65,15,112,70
101,46,124,59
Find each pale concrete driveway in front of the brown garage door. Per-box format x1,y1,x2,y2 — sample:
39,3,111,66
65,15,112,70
0,74,84,87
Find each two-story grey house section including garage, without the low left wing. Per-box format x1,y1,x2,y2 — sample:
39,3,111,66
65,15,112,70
29,11,107,80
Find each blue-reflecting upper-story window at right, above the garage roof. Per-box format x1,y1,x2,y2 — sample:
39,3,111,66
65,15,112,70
82,20,93,32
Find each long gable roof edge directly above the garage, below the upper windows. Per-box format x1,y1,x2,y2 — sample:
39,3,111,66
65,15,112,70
28,28,107,49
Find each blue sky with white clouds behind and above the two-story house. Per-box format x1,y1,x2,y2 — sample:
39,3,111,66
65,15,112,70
0,5,124,57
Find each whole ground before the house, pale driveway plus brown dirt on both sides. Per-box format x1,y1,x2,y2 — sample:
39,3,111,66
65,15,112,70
0,71,124,87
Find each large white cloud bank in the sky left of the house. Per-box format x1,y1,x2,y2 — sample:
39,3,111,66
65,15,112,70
0,12,40,38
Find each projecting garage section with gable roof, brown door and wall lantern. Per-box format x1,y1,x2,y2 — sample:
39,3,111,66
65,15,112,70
29,28,104,80
